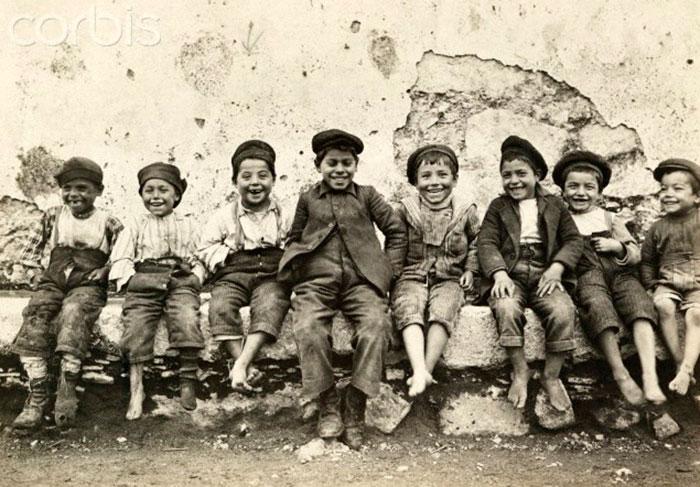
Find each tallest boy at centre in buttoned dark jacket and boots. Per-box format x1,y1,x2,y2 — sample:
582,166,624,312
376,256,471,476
278,129,406,449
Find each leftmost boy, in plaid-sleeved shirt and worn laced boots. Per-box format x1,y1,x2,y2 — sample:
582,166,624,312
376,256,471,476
12,157,122,429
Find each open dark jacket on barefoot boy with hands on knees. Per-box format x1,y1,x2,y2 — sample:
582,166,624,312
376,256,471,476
477,185,583,298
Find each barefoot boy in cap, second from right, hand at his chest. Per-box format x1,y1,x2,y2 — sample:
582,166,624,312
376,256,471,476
552,151,666,406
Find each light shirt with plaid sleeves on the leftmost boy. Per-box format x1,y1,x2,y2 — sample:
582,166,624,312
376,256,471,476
13,205,123,269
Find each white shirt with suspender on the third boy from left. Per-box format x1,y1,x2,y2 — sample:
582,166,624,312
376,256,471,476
197,198,291,272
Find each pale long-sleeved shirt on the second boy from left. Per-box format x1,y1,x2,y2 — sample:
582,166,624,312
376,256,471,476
109,213,205,290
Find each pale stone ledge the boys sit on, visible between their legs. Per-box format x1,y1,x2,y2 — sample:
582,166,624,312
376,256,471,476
0,293,666,369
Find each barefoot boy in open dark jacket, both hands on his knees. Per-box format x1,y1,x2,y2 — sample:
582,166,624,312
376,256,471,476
477,135,583,411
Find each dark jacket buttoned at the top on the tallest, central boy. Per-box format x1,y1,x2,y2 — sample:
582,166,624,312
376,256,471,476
277,181,406,293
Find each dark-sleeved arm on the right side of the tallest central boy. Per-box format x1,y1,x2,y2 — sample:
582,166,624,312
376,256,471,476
367,186,408,276
